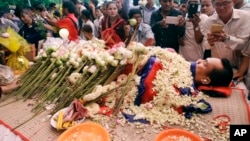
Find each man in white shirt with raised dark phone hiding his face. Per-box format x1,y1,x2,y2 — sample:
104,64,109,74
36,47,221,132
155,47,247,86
179,0,208,61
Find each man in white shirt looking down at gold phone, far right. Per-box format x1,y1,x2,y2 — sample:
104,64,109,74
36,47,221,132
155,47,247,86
205,0,250,98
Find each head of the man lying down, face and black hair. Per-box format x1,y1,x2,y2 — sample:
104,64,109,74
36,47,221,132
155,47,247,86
194,58,233,86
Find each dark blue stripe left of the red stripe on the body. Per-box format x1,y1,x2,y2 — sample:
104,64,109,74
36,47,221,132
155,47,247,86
134,56,156,106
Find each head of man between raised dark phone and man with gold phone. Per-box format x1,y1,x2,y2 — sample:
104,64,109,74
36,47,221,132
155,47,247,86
201,0,214,16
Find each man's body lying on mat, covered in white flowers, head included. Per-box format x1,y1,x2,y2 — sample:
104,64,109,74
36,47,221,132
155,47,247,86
15,38,232,141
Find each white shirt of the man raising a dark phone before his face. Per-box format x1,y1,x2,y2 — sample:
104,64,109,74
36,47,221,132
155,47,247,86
179,14,208,61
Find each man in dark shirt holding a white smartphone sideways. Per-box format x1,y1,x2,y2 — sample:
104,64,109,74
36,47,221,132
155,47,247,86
150,0,185,52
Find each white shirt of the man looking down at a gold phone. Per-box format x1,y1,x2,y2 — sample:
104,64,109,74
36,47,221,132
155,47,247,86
204,9,250,67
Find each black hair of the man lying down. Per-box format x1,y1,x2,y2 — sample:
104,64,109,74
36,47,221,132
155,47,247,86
209,58,233,86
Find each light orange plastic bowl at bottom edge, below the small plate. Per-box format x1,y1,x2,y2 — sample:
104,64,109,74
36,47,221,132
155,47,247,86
57,122,110,141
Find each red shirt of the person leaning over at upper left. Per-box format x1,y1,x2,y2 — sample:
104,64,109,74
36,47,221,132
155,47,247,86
56,14,78,41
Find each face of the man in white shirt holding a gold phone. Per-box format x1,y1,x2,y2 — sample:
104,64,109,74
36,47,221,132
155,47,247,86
214,0,233,18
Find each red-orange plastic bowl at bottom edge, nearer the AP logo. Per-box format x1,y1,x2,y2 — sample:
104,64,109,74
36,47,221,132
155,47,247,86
155,129,202,141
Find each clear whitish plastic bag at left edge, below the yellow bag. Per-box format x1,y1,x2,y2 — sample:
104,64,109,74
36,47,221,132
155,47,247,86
0,65,15,86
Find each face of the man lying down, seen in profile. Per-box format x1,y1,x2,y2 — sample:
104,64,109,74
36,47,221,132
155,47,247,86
195,58,223,81
